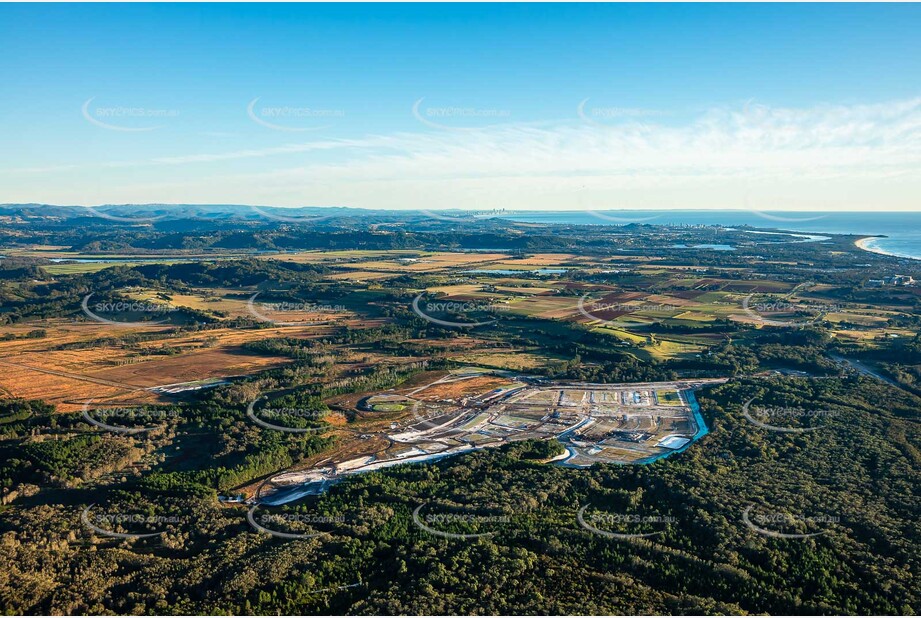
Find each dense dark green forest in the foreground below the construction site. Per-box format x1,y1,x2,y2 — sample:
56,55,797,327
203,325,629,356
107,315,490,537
0,378,921,614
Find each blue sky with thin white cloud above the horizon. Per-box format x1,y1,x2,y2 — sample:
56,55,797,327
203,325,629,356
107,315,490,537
0,4,921,211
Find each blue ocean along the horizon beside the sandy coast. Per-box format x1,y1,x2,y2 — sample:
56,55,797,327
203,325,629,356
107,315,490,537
498,210,921,260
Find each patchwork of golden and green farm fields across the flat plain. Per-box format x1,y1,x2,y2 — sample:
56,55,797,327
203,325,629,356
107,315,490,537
0,236,912,411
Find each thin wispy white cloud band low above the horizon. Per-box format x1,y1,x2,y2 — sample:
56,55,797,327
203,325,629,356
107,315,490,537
1,98,921,208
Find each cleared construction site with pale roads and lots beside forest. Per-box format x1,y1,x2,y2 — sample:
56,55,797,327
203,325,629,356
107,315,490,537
260,370,725,504
